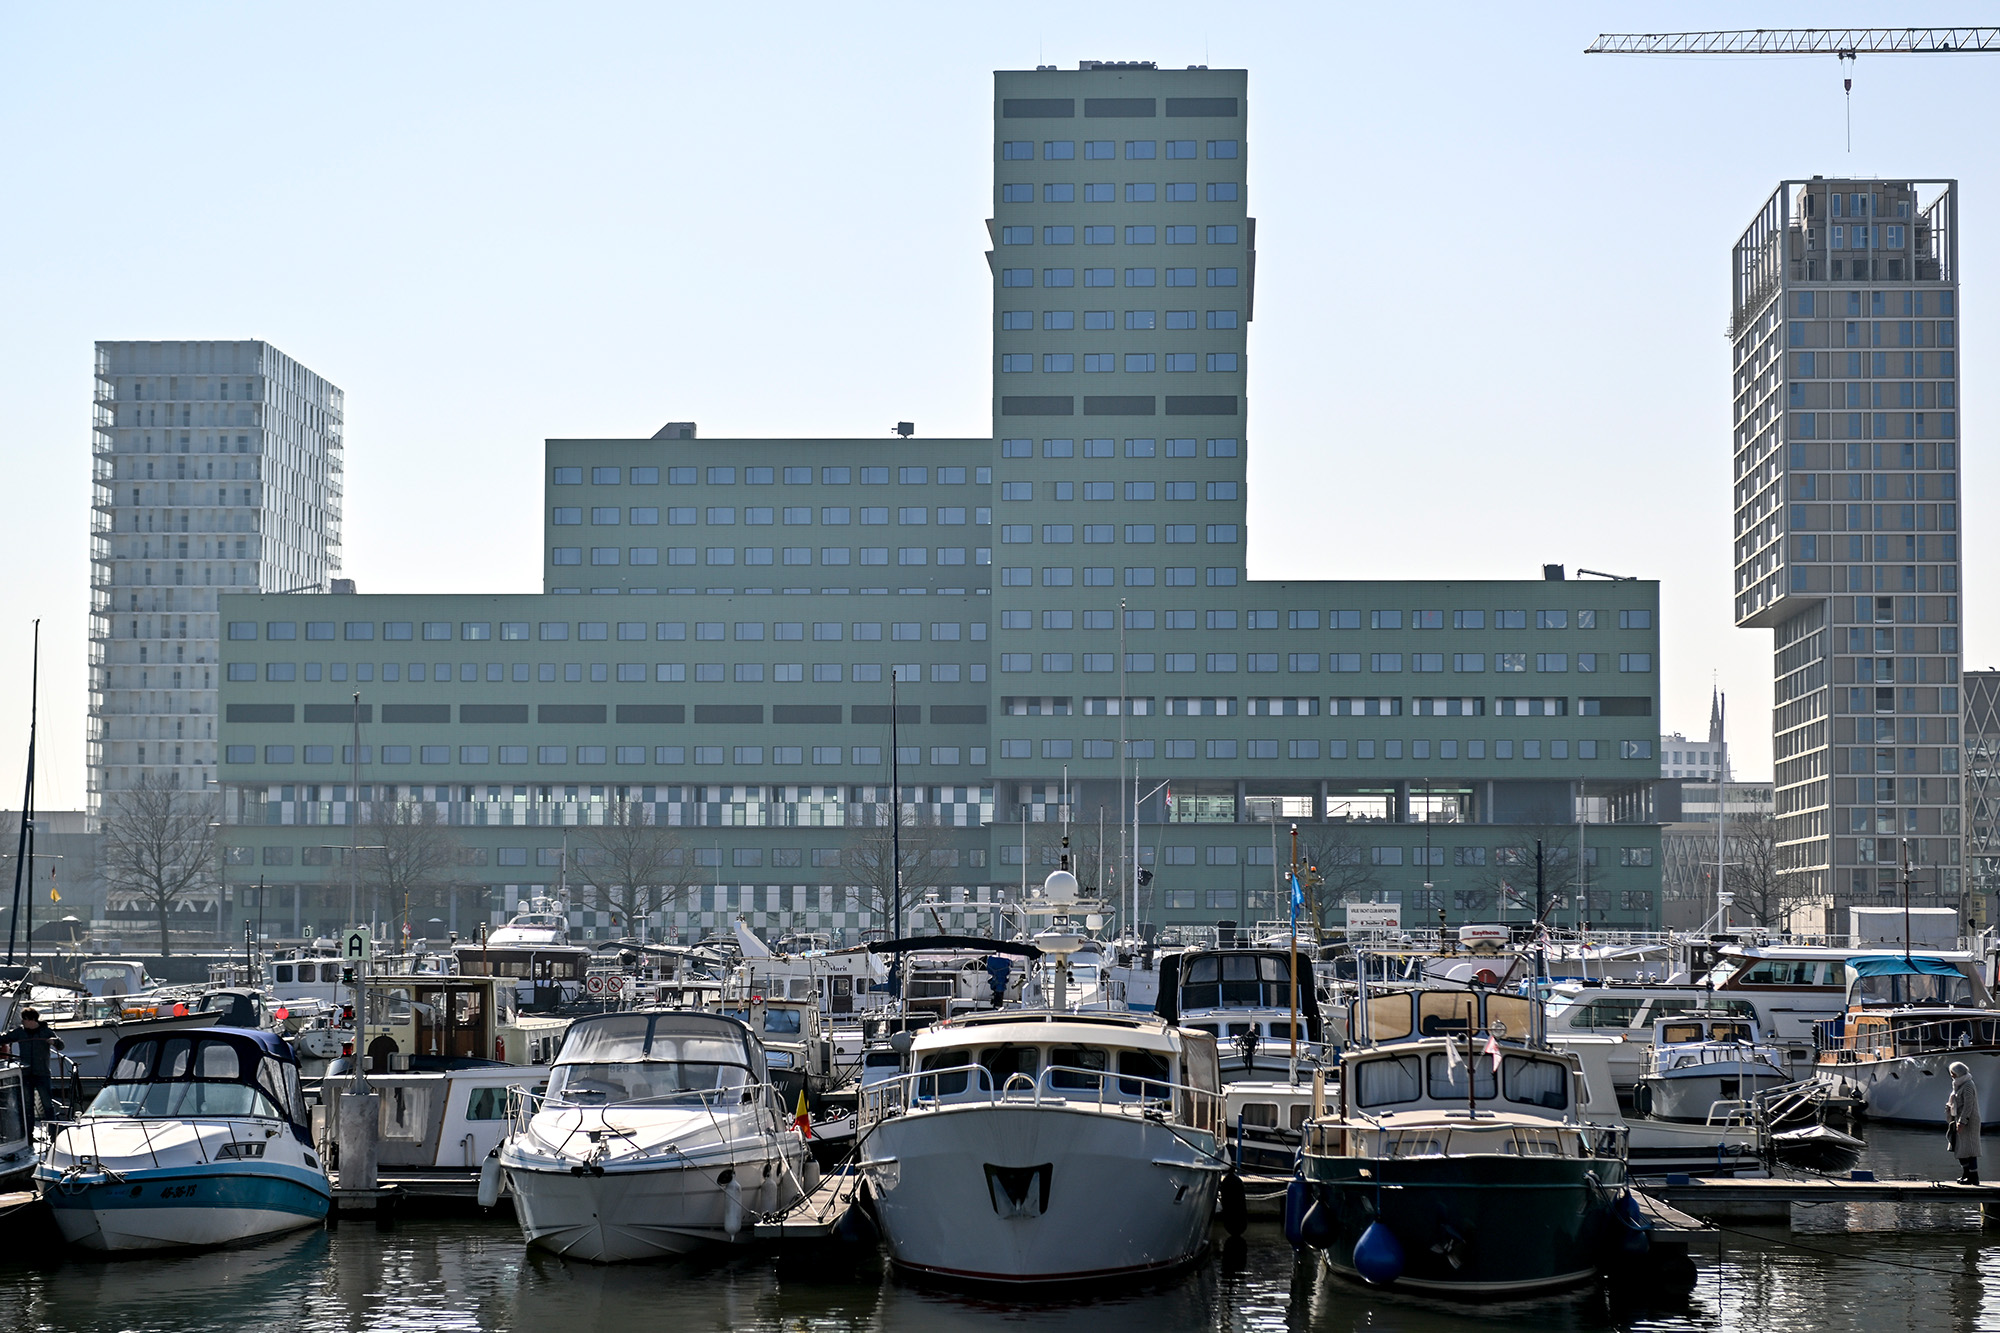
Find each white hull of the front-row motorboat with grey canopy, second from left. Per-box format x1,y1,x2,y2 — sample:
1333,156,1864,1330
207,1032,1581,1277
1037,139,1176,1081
506,1153,798,1263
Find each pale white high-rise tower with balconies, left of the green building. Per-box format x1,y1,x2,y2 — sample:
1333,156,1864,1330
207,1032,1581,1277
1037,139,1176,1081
86,340,344,815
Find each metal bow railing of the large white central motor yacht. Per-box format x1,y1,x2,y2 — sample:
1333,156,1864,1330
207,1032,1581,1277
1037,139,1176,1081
860,1065,1228,1133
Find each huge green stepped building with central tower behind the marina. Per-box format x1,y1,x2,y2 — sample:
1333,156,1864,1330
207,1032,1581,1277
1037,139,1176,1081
211,62,1660,939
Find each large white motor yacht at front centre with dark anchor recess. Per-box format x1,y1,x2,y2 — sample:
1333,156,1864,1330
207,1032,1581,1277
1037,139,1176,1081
856,1011,1226,1285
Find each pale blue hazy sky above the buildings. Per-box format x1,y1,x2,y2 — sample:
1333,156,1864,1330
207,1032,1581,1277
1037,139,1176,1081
0,0,2000,809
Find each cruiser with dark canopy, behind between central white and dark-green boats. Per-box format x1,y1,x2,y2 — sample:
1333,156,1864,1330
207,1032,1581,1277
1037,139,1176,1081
1154,949,1324,1083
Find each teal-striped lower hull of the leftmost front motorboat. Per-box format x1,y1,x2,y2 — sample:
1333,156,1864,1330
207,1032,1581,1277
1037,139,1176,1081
44,1167,332,1253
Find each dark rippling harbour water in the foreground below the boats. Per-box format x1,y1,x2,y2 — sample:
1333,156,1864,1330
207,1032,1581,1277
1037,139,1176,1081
11,1129,2000,1333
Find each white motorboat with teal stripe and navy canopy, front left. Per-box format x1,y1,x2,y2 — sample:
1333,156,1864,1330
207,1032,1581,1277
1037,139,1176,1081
36,1027,332,1251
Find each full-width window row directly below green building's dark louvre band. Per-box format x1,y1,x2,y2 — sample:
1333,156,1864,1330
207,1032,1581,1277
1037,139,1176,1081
222,739,1652,769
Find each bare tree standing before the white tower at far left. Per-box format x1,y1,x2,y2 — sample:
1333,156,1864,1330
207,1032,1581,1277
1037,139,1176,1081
104,773,220,955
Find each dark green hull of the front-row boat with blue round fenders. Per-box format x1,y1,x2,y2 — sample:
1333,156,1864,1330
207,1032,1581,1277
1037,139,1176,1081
1302,1155,1626,1299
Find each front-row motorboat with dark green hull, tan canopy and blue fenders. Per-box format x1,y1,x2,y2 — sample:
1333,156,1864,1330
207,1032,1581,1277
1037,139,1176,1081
1296,989,1628,1299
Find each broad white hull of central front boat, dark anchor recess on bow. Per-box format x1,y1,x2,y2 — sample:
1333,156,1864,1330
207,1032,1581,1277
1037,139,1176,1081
862,1103,1220,1283
